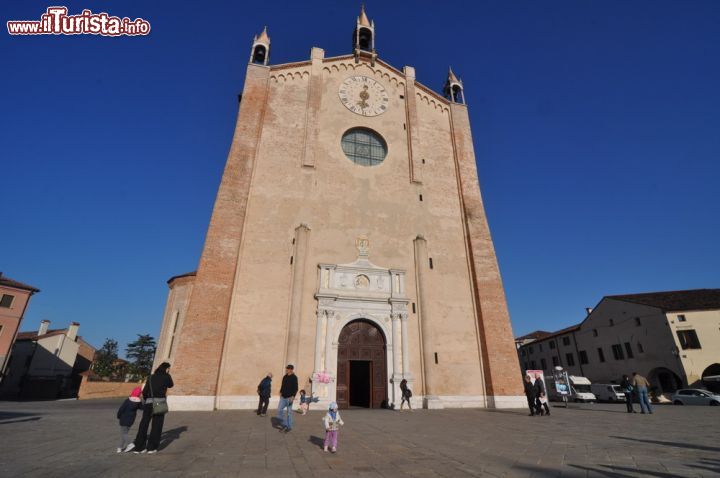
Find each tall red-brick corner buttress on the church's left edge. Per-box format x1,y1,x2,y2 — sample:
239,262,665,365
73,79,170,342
173,64,269,396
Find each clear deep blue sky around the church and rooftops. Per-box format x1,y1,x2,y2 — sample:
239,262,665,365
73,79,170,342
0,0,720,347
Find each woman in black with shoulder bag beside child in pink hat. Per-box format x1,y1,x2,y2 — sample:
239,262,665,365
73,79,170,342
125,362,174,454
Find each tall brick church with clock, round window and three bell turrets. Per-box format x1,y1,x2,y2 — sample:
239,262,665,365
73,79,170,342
156,7,526,410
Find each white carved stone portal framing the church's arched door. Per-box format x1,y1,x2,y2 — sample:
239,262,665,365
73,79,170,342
313,237,413,408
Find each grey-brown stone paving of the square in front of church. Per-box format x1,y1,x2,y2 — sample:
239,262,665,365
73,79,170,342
0,400,720,478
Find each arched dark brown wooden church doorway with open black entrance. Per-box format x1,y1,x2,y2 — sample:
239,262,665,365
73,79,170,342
336,319,387,408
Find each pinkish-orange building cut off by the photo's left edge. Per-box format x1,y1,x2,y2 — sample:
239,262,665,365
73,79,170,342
0,272,40,383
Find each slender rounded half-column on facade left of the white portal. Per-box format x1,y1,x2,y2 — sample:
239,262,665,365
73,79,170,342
285,224,310,364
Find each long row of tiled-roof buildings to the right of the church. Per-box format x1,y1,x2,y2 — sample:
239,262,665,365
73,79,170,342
518,289,720,393
